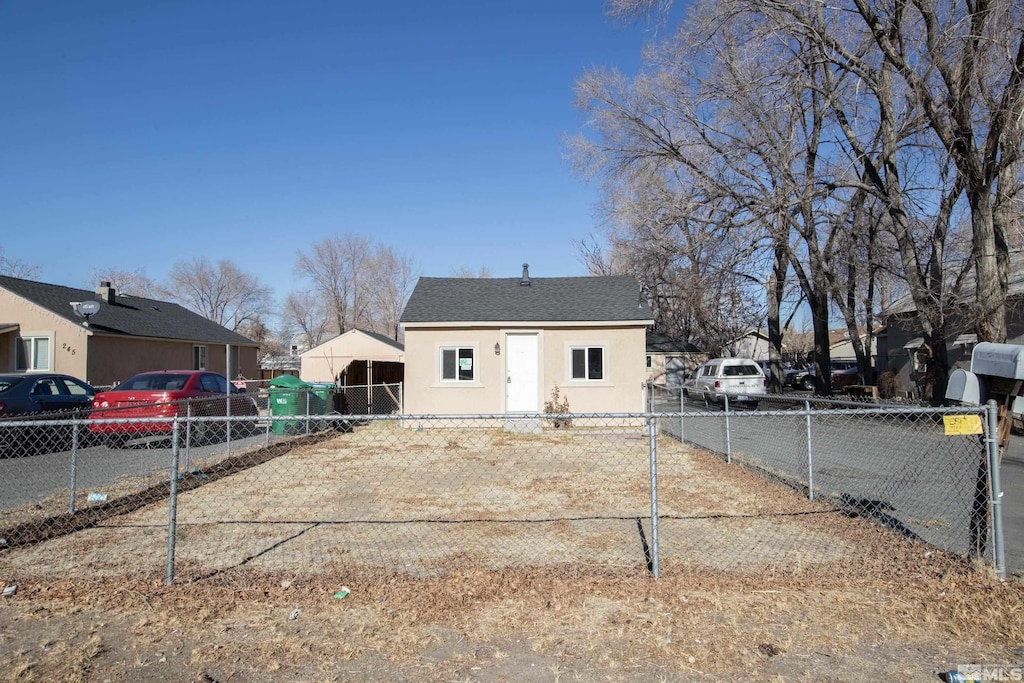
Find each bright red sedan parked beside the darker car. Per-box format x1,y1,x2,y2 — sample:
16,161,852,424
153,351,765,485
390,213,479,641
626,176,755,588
89,370,259,440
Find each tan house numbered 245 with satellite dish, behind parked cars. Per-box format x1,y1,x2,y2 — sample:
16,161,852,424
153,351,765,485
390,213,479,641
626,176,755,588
0,275,259,386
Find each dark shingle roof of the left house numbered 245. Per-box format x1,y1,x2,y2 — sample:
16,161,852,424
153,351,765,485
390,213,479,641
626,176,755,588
0,275,256,346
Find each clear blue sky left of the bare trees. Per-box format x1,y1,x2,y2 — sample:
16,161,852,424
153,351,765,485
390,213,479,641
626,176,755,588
0,0,649,313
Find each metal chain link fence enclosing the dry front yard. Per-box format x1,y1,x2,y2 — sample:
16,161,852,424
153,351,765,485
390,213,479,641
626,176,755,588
0,401,1002,584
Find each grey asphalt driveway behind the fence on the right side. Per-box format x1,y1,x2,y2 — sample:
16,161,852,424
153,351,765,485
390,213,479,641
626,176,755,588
655,398,1024,577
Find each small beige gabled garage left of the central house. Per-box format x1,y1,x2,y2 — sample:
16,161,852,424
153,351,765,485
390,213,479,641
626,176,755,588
299,330,406,386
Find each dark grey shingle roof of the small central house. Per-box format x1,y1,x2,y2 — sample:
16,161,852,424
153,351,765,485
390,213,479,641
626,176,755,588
401,275,653,323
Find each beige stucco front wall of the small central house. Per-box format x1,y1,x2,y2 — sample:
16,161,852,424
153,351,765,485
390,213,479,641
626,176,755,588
404,323,646,415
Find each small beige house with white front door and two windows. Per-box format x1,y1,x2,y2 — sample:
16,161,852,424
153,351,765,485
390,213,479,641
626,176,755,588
400,266,653,415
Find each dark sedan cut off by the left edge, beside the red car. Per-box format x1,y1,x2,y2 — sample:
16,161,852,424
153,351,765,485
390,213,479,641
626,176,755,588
0,373,96,455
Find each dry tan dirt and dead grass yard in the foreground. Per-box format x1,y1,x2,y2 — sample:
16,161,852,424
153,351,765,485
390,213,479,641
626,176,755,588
0,429,1024,682
